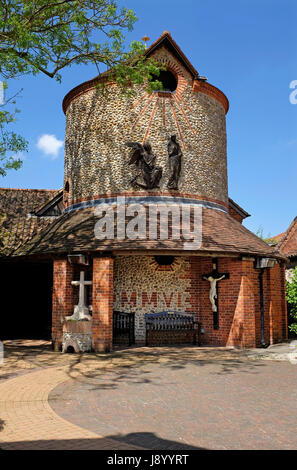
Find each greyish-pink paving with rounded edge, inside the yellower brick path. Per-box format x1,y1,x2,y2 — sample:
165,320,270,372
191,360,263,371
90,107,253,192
49,359,297,450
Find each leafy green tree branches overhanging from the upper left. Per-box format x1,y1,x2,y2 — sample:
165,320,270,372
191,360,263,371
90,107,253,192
0,0,161,175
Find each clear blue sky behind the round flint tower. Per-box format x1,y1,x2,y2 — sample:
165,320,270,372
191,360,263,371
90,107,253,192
0,0,297,235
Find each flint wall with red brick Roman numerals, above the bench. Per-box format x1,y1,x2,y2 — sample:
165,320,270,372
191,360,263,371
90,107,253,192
114,256,192,343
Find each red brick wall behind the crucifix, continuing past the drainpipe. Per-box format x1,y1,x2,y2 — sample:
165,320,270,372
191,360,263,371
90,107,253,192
188,257,287,348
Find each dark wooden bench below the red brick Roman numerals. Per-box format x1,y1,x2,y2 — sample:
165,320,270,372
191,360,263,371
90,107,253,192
145,311,201,346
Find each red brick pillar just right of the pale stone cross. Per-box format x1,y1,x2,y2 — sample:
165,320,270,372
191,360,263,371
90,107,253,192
92,257,114,352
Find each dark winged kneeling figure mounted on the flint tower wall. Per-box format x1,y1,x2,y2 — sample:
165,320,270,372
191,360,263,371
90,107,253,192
125,141,163,189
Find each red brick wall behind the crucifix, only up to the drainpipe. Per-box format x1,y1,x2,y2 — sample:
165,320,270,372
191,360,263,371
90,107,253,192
187,257,259,347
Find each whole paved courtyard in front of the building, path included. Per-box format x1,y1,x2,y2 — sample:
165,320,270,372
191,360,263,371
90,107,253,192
0,341,297,450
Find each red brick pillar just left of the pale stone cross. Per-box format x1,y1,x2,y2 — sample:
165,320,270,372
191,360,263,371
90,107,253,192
52,259,73,351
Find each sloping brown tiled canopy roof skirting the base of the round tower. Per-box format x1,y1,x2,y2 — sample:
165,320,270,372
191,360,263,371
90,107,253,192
14,207,284,258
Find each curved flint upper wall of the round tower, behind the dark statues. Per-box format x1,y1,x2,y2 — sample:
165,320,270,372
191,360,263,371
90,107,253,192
64,47,228,206
